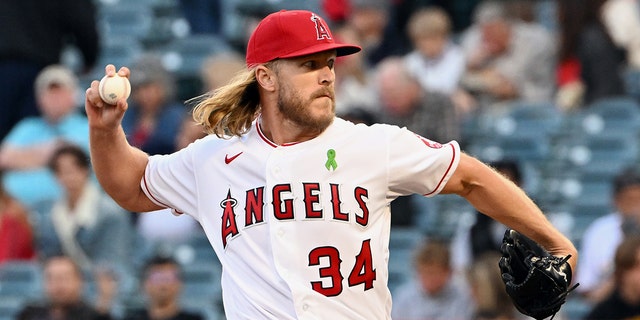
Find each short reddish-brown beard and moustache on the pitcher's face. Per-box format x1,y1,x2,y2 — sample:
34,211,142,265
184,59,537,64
278,85,336,133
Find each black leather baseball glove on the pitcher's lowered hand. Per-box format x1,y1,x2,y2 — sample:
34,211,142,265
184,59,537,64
498,229,578,320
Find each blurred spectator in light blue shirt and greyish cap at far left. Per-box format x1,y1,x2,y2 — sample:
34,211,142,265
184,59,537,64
0,65,89,209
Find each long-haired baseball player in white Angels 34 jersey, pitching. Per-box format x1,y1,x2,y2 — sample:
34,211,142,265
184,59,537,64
85,10,576,320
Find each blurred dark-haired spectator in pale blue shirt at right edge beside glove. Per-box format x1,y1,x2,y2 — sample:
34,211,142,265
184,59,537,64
576,167,640,303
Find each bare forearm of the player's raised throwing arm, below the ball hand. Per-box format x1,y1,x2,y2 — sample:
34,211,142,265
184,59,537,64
89,127,158,212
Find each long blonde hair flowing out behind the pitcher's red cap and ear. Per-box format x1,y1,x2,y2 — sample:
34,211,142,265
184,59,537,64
189,67,260,138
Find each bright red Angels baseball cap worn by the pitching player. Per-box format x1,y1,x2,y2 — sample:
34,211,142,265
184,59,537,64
246,10,362,66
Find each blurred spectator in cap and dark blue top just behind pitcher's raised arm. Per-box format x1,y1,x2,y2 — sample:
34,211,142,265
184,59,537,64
122,54,188,154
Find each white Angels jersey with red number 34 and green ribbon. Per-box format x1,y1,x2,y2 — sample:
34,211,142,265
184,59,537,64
141,118,460,320
